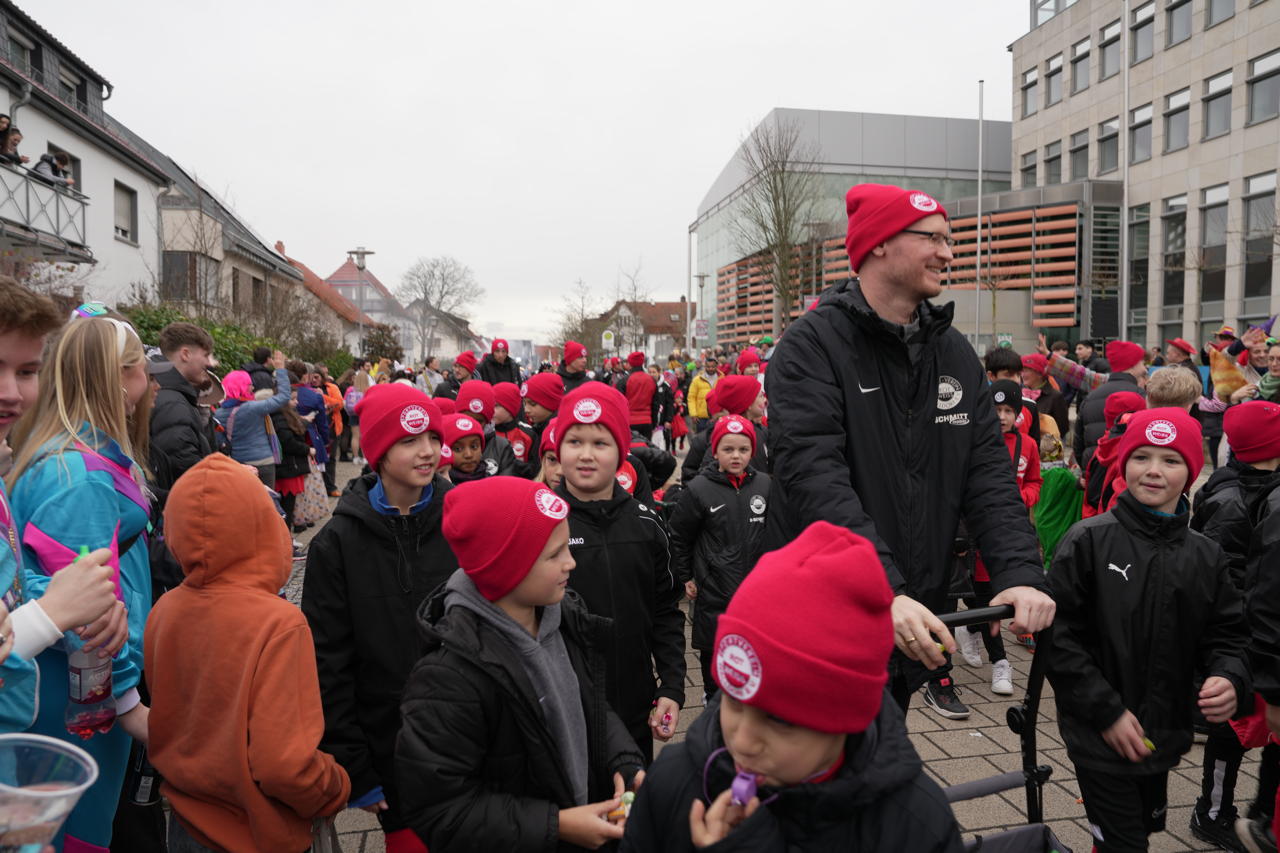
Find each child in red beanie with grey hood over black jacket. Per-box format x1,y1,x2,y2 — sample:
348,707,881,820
396,476,641,850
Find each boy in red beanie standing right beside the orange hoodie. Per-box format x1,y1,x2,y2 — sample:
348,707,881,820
302,383,458,853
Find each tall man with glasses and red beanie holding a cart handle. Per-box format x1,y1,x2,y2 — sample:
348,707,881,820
765,183,1053,719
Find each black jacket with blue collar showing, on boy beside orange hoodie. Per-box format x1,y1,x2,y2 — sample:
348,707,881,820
302,474,458,833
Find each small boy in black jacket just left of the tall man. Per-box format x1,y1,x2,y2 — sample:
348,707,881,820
671,415,769,698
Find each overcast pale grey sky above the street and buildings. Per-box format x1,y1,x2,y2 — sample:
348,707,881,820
42,0,1028,338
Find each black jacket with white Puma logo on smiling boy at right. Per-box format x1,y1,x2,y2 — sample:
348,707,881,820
1048,492,1252,775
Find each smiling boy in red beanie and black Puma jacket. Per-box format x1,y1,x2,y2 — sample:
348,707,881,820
1048,409,1249,853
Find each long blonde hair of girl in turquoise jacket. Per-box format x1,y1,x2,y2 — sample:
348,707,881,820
9,318,151,488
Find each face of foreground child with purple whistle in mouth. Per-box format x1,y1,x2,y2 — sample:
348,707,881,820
721,693,846,786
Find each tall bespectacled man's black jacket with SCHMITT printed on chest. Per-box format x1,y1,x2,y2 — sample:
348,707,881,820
765,279,1048,612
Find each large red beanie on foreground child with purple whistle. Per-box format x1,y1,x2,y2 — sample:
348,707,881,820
712,521,893,734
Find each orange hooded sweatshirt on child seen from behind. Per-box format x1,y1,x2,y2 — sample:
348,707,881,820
143,453,351,853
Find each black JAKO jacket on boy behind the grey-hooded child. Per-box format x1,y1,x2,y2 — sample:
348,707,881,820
558,482,685,752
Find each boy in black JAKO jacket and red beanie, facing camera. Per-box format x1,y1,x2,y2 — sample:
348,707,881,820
556,382,685,763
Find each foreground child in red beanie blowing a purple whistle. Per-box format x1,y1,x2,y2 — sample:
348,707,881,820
622,521,963,853
